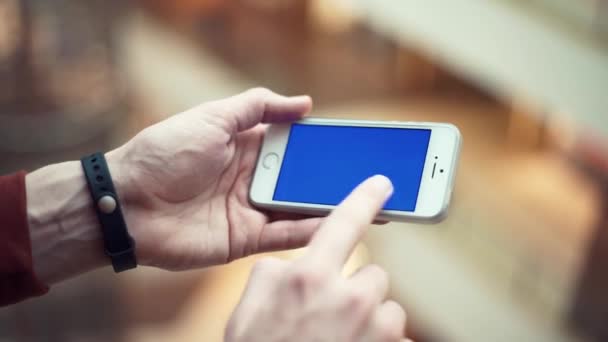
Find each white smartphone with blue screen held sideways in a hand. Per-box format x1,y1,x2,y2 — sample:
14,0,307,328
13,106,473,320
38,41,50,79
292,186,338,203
249,118,461,223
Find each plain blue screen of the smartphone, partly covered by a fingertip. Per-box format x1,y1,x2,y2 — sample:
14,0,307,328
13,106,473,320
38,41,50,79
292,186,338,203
273,124,431,211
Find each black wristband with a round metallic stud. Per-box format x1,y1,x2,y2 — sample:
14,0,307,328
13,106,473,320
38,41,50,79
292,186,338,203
81,153,137,273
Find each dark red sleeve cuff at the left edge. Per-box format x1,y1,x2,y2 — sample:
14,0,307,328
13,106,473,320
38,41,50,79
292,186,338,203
0,171,48,306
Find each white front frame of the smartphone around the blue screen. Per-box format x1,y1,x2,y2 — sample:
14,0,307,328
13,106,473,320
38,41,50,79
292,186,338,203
249,118,461,223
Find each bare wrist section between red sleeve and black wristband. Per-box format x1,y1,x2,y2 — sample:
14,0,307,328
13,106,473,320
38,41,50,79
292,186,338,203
26,161,109,284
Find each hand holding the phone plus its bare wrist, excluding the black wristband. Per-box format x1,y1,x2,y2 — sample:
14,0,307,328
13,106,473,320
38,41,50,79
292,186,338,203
26,89,320,284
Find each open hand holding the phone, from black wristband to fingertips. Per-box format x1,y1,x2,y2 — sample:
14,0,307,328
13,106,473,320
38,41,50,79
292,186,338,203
107,89,320,270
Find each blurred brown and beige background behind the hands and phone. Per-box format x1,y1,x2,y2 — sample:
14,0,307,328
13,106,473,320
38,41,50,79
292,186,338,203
0,0,608,342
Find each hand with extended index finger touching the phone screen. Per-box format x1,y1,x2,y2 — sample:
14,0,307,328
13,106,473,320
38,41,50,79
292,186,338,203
226,176,405,342
